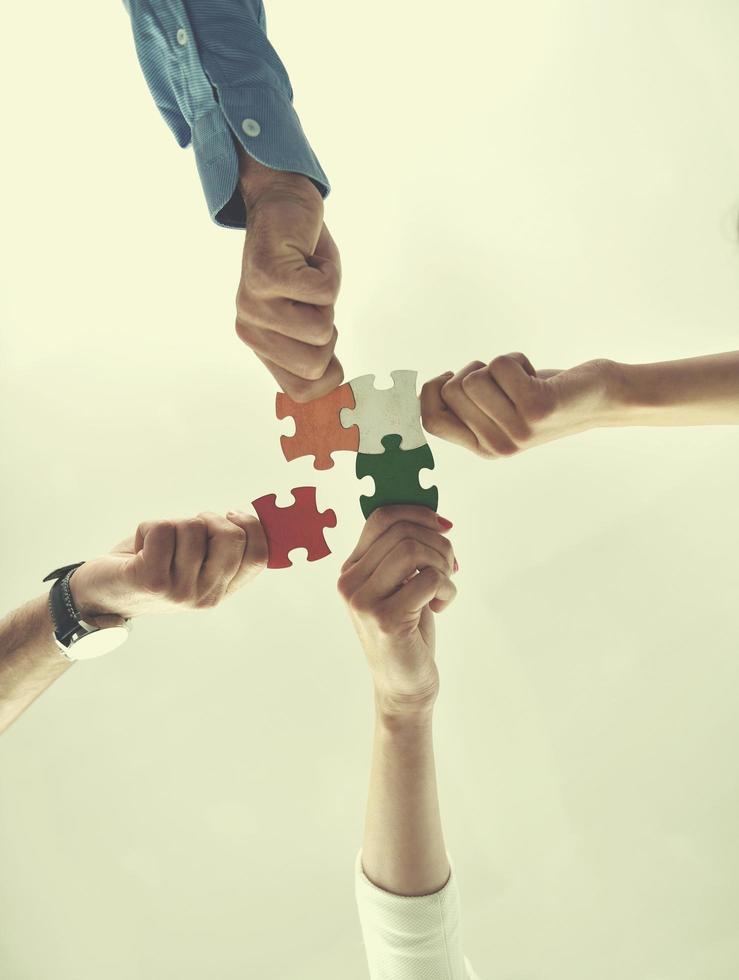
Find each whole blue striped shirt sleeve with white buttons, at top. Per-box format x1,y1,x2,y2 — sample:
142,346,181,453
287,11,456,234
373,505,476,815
123,0,331,229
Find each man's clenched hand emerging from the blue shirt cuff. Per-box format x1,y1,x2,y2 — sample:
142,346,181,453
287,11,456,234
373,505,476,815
236,149,344,402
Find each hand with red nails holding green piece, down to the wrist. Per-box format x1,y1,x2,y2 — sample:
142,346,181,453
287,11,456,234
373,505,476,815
338,505,459,716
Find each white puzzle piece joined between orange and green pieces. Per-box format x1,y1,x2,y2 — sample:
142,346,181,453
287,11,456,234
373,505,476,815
340,371,427,454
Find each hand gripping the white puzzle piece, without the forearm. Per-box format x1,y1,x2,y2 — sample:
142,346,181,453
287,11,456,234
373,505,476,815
421,353,616,459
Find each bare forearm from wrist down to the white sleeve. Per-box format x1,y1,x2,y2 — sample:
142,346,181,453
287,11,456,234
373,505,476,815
362,709,451,895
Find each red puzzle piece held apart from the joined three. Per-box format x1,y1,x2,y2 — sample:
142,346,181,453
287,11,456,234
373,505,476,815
251,487,336,568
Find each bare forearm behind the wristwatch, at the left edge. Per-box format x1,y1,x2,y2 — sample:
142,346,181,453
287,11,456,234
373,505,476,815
0,595,72,732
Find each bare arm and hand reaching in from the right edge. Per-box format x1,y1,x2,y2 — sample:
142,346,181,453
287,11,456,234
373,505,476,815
421,351,739,459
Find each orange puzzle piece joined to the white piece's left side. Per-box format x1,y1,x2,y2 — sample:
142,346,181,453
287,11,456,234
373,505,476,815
275,384,359,470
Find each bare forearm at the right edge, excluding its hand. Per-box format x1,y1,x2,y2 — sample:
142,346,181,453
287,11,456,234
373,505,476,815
603,351,739,426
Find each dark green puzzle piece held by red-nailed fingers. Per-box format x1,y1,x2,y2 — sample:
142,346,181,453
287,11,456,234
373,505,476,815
356,435,439,519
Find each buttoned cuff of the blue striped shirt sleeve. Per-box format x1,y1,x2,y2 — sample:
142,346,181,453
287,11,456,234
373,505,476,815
192,86,331,229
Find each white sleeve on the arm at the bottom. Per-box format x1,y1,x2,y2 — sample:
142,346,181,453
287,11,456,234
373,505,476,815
355,850,469,980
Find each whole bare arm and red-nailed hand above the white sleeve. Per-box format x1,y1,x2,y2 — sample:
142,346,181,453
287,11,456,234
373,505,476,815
339,506,458,896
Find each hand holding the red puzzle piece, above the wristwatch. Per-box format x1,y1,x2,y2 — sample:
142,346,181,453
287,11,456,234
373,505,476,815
69,513,267,626
